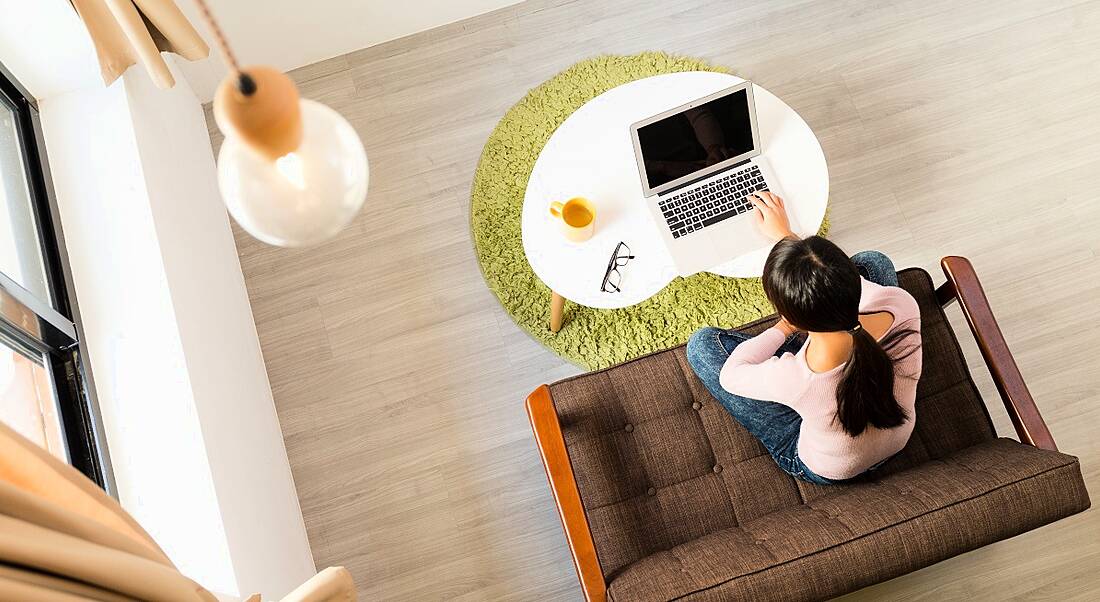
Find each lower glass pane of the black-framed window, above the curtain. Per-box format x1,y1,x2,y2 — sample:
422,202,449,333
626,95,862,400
0,342,68,462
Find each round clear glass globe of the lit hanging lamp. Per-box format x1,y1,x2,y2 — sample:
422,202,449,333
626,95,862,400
218,99,370,247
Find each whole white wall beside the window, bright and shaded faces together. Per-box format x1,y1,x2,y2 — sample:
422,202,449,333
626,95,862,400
40,63,315,596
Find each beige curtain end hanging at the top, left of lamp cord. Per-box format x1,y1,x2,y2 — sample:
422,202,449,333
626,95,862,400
69,0,210,88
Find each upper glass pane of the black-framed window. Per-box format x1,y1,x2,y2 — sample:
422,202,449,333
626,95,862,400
0,99,51,303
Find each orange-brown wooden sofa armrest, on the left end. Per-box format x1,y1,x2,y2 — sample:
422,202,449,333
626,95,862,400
527,385,607,602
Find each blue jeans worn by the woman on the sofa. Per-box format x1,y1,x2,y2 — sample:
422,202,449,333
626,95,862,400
688,251,898,485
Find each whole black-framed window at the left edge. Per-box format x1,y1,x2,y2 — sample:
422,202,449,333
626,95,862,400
0,58,109,489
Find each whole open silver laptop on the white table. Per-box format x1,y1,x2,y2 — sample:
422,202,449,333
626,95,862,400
630,81,798,276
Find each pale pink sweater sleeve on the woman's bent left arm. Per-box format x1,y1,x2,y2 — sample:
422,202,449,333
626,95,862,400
718,328,804,407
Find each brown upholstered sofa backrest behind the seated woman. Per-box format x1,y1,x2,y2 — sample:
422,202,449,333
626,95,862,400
608,439,1089,601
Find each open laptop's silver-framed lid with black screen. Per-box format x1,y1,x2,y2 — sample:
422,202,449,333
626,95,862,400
630,81,760,197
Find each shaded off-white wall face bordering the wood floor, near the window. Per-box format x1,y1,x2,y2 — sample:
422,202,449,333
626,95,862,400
123,62,315,595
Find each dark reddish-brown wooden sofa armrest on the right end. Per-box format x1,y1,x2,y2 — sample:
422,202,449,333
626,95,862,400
936,255,1058,451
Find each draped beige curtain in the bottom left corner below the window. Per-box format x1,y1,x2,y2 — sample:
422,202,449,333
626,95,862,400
0,423,355,602
